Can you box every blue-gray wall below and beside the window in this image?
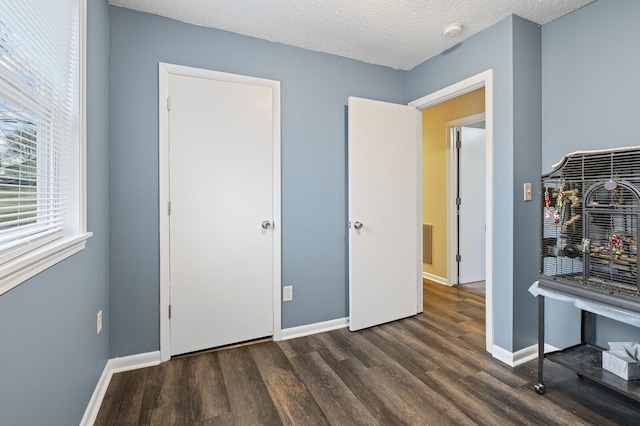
[0,0,109,426]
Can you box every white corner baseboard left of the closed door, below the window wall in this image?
[80,351,160,426]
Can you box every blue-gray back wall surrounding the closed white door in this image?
[110,7,406,356]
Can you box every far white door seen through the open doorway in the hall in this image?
[458,127,486,284]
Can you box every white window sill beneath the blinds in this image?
[0,232,93,295]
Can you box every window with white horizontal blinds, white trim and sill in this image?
[0,0,91,294]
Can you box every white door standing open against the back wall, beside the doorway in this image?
[348,97,422,330]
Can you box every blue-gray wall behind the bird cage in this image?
[542,0,640,347]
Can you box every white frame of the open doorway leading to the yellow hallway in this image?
[409,69,494,354]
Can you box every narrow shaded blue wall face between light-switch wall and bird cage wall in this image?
[512,17,542,351]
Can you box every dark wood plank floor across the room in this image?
[95,281,640,425]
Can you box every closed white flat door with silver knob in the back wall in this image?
[168,73,279,355]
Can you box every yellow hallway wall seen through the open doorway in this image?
[422,88,484,279]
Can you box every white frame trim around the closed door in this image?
[158,62,282,362]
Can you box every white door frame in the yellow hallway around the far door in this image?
[447,112,486,286]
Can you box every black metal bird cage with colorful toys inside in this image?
[540,147,640,310]
